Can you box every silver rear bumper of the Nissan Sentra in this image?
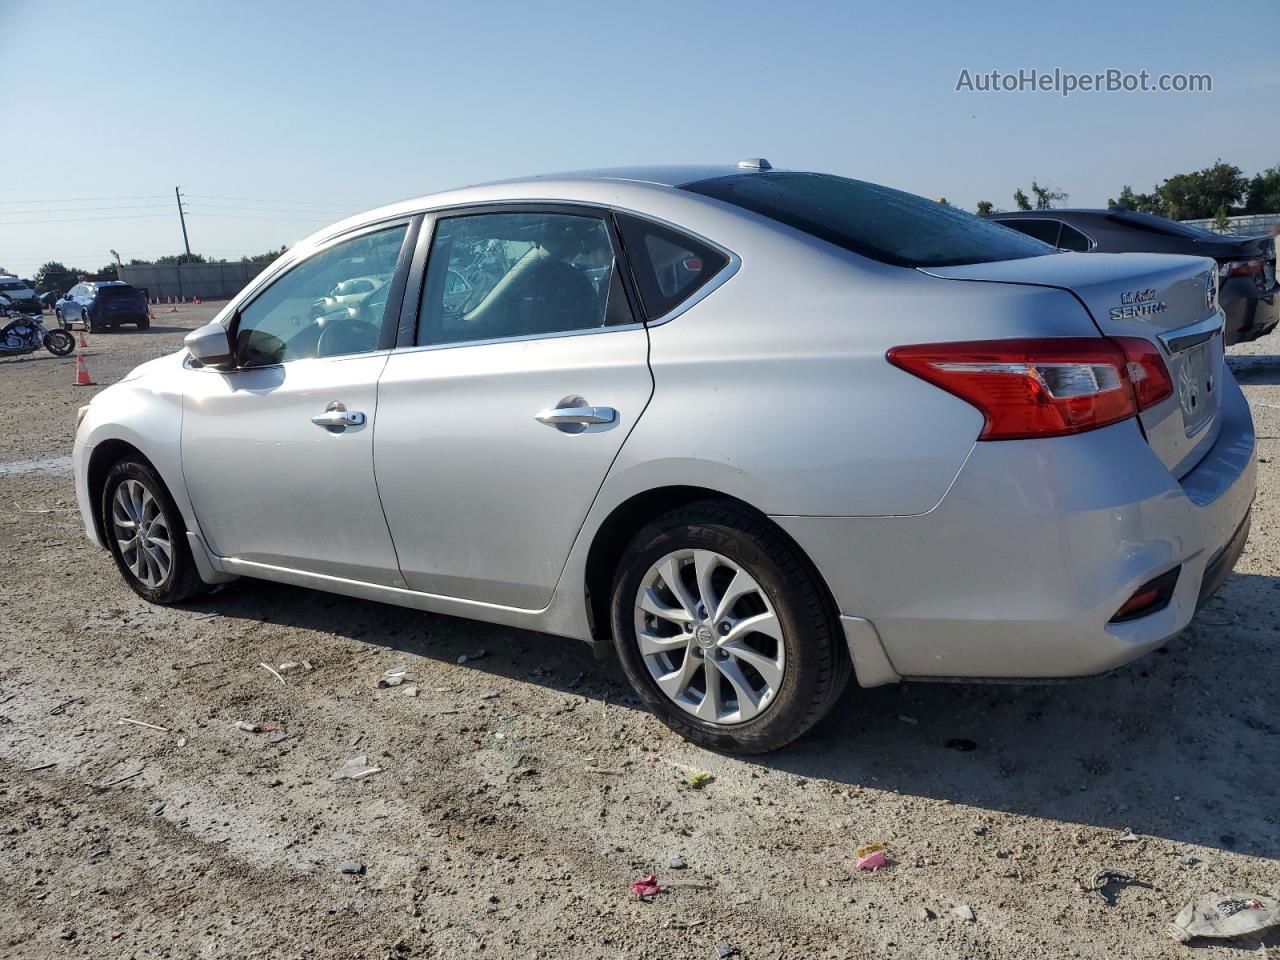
[776,376,1256,682]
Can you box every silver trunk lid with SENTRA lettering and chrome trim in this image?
[925,253,1224,477]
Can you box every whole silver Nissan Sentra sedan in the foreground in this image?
[73,161,1256,751]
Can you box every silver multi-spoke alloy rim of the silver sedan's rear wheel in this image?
[635,549,786,724]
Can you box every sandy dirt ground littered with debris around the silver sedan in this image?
[0,305,1280,960]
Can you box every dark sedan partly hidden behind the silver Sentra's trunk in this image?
[989,209,1280,344]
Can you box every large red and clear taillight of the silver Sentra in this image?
[888,337,1172,440]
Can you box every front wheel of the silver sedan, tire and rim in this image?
[100,460,207,603]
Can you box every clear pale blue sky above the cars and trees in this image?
[0,0,1280,275]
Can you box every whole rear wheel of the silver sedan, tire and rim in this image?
[612,500,850,753]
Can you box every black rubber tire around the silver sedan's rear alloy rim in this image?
[609,500,852,754]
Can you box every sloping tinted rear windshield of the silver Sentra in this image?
[684,173,1055,266]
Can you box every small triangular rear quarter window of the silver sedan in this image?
[617,214,728,320]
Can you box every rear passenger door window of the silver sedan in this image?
[417,212,632,346]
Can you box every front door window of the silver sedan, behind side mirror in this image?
[236,225,408,366]
